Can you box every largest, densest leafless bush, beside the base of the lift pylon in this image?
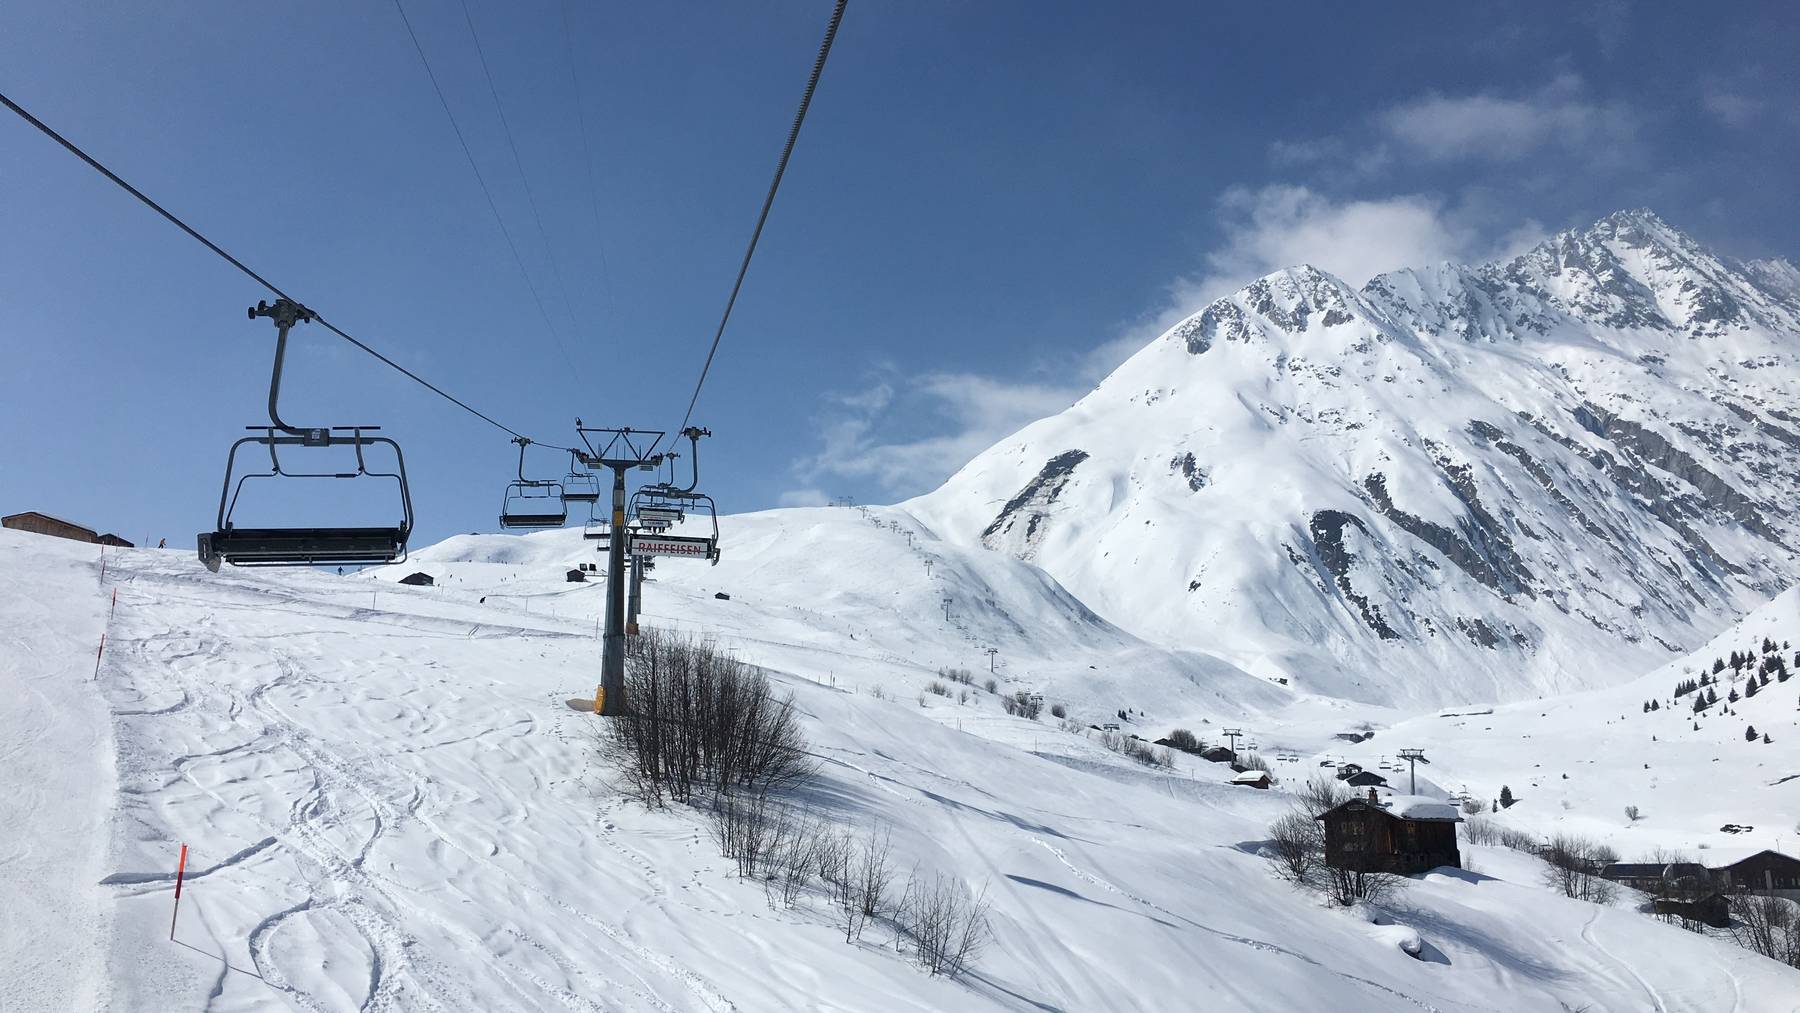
[603,630,817,806]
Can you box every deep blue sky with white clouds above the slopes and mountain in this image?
[0,0,1800,545]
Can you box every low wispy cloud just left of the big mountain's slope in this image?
[783,372,1085,502]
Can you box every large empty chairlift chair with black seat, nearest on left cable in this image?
[196,299,412,572]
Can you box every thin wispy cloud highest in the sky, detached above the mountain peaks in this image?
[1375,74,1636,162]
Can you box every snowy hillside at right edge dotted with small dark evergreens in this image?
[1330,588,1800,862]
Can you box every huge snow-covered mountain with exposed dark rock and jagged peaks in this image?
[904,211,1800,705]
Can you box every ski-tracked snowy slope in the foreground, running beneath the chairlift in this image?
[0,511,1800,1011]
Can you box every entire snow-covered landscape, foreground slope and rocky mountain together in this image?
[10,212,1800,1013]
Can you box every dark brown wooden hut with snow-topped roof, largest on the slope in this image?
[1319,788,1462,874]
